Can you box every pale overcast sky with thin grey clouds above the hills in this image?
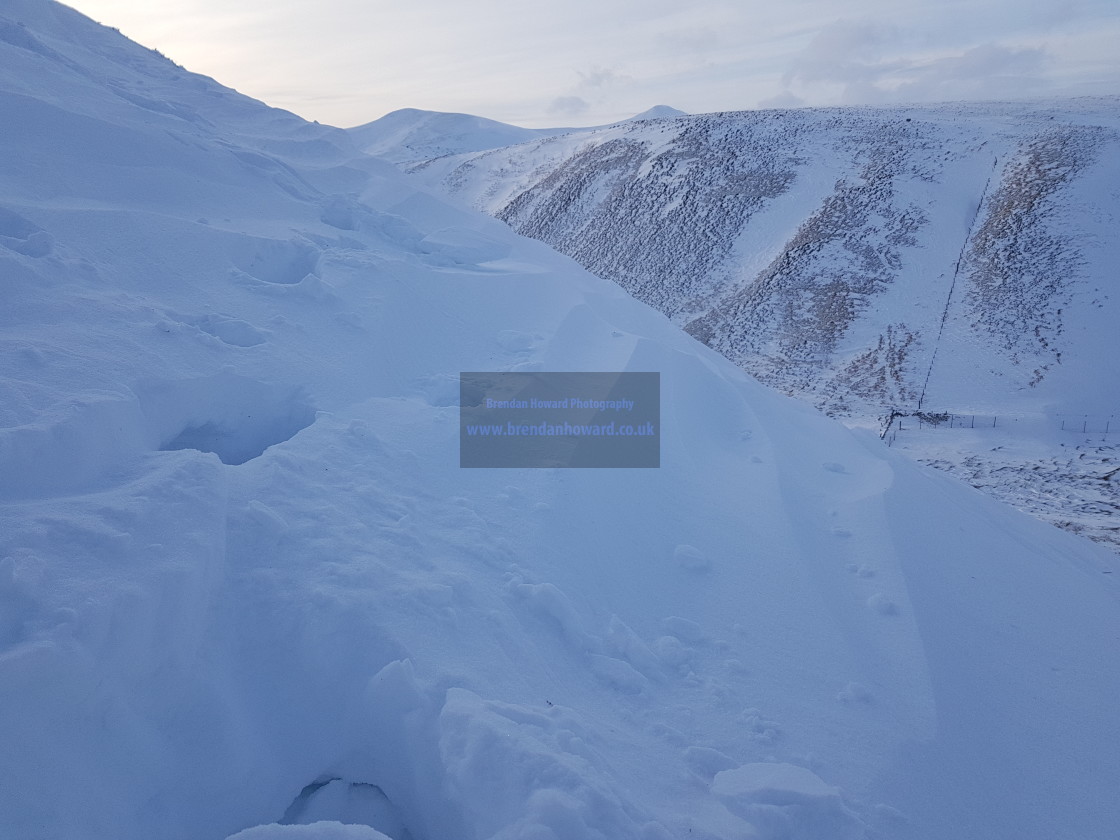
[68,0,1120,128]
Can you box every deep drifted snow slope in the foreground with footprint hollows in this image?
[0,0,1120,840]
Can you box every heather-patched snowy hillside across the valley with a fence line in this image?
[412,97,1120,545]
